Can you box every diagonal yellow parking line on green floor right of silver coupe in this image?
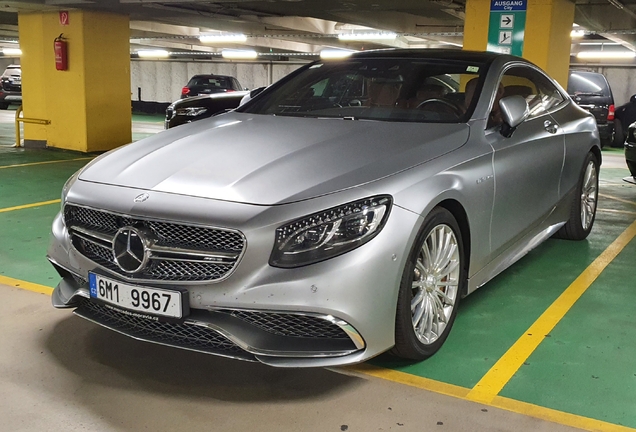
[468,221,636,403]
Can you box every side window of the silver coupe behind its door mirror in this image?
[493,66,565,118]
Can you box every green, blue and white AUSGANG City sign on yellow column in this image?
[487,0,528,56]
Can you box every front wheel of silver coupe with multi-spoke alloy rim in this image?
[391,207,467,360]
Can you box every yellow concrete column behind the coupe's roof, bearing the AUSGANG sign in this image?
[464,0,574,87]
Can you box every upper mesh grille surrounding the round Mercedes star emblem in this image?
[64,204,245,282]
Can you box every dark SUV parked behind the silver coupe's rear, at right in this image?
[568,70,615,146]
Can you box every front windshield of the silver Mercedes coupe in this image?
[241,58,486,123]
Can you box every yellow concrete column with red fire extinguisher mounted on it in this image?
[18,10,131,152]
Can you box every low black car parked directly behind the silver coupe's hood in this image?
[164,91,249,129]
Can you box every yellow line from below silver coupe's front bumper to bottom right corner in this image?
[348,364,636,432]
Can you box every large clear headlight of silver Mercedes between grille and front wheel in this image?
[269,195,392,268]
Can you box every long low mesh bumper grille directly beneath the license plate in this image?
[76,299,249,358]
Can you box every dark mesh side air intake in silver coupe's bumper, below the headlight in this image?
[230,310,349,340]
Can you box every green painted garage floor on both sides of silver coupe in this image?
[0,135,636,428]
